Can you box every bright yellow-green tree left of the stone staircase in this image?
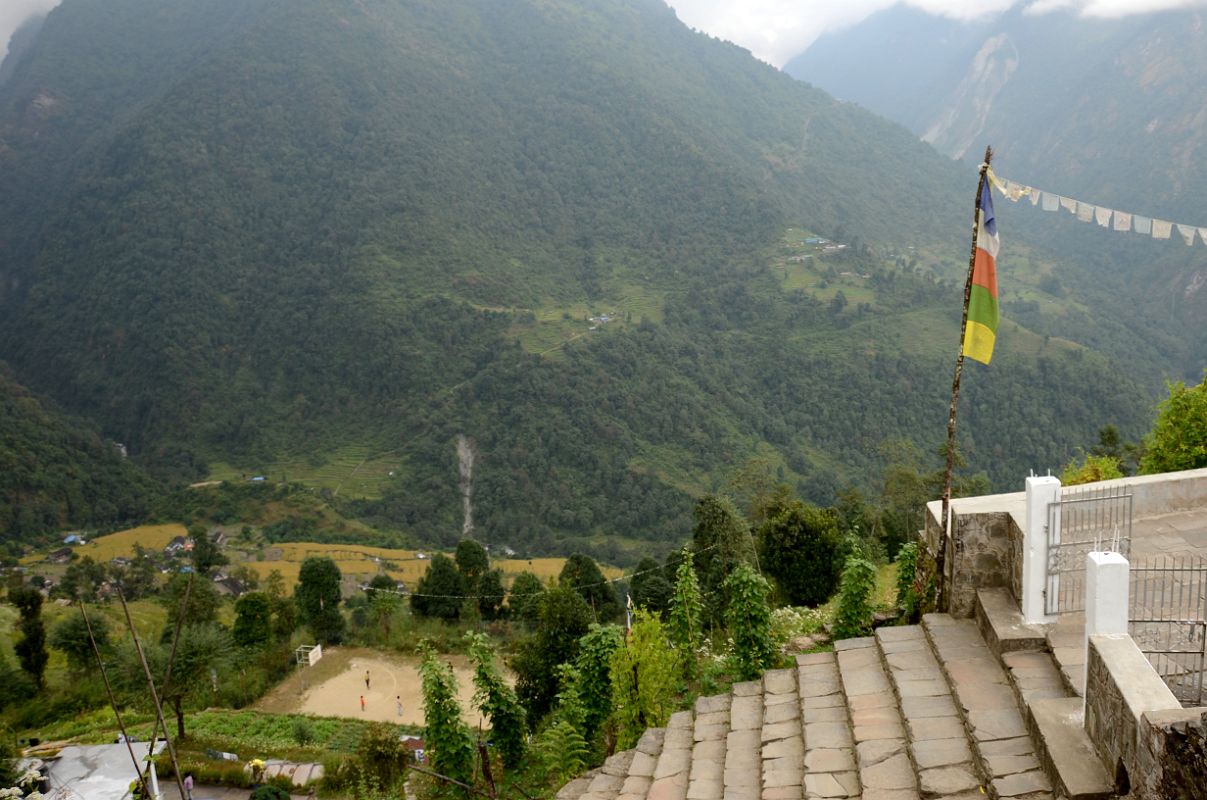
[612,608,678,749]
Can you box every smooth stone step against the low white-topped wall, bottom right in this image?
[1027,697,1115,800]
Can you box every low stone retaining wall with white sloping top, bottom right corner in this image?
[1085,635,1207,800]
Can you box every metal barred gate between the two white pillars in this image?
[1044,486,1132,614]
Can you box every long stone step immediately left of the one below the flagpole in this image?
[876,625,984,798]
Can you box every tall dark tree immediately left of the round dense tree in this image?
[692,495,754,621]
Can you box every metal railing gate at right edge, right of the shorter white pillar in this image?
[1127,556,1207,707]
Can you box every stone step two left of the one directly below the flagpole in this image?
[835,636,907,800]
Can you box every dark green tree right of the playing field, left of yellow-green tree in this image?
[512,585,594,725]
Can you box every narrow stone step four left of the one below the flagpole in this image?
[760,668,805,800]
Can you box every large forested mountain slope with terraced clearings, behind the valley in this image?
[0,0,1164,548]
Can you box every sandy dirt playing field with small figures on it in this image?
[256,648,504,729]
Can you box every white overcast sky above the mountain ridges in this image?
[7,0,1207,66]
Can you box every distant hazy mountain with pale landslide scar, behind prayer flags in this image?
[786,4,1207,371]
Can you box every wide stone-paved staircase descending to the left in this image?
[558,603,1114,800]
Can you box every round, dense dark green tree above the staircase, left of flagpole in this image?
[758,501,844,606]
